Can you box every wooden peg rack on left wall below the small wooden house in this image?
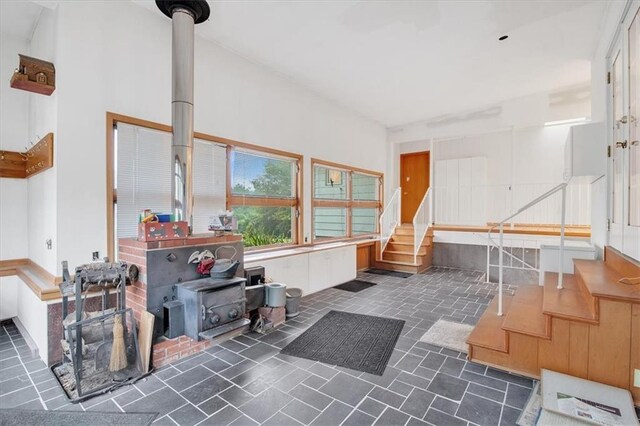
[0,133,53,179]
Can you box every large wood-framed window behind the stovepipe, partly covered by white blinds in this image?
[107,113,302,259]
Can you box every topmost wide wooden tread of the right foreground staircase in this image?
[573,259,640,303]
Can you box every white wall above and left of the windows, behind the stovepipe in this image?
[16,1,389,274]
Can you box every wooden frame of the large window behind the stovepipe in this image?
[106,112,304,259]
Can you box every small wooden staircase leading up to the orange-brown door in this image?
[375,224,433,274]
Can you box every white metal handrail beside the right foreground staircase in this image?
[487,182,568,316]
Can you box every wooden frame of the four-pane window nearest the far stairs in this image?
[311,158,384,244]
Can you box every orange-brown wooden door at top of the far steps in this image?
[400,151,429,223]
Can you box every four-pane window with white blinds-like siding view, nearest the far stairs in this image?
[312,160,382,241]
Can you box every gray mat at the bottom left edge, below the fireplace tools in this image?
[0,408,158,426]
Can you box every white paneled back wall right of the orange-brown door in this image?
[432,125,591,225]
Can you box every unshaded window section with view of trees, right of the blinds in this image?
[228,147,300,247]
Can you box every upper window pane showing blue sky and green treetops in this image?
[231,151,295,198]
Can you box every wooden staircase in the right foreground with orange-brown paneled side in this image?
[467,247,640,404]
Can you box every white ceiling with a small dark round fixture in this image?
[0,0,608,127]
